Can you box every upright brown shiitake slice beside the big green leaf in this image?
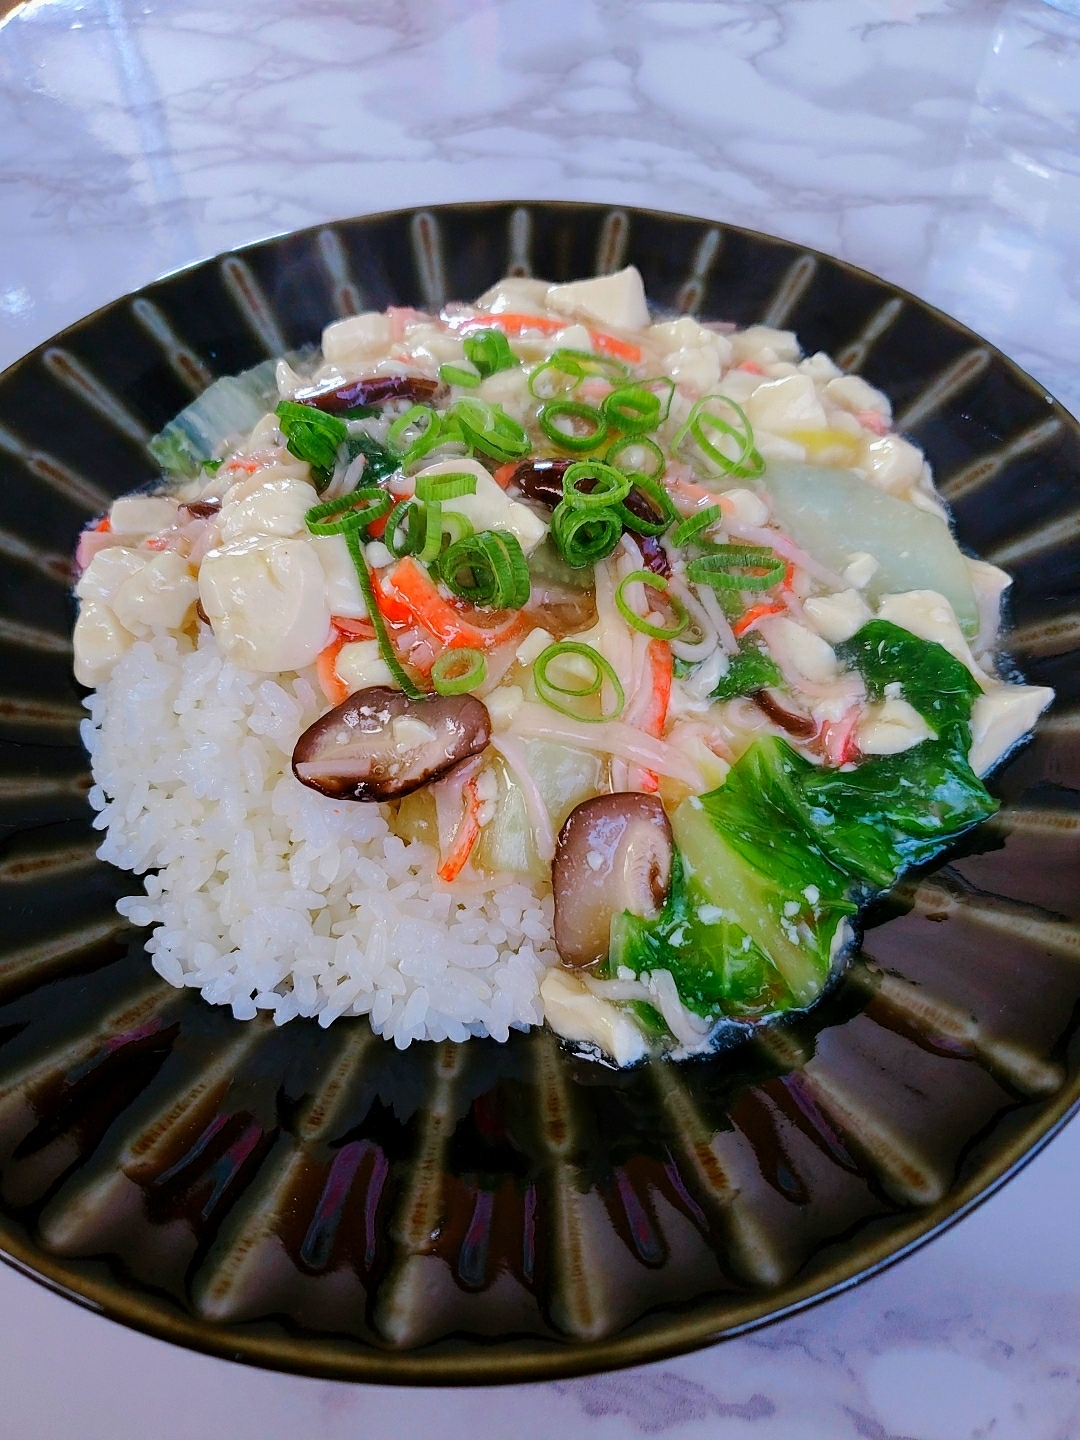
[552,791,674,969]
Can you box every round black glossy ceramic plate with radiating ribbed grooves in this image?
[0,203,1080,1384]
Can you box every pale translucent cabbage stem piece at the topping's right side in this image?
[757,461,979,636]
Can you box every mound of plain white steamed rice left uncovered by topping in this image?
[82,631,559,1048]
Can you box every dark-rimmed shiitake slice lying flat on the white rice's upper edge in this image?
[292,685,491,801]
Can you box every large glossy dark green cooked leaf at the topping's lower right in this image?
[611,621,996,1015]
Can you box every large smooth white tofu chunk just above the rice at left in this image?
[199,536,330,672]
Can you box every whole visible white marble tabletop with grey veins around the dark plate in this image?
[0,0,1080,1440]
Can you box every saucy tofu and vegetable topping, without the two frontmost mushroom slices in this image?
[75,269,1051,1063]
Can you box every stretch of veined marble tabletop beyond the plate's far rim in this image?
[0,0,1080,408]
